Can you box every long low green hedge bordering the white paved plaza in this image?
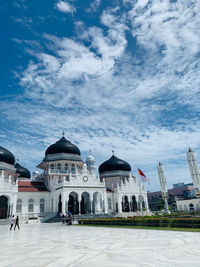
[78,217,200,228]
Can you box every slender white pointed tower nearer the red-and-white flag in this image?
[157,162,170,214]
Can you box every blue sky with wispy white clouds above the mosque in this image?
[0,0,200,193]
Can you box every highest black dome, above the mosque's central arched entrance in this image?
[45,136,81,156]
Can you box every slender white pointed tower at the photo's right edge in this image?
[187,148,200,199]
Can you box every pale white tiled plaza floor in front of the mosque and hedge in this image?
[0,224,200,267]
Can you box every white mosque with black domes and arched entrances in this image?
[0,133,149,219]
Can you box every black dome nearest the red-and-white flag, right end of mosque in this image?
[99,155,131,173]
